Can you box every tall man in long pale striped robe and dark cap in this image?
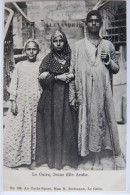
[69,10,125,170]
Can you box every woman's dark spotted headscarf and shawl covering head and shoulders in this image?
[39,30,71,75]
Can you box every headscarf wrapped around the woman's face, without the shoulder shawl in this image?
[50,30,71,60]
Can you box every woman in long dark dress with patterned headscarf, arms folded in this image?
[36,31,77,169]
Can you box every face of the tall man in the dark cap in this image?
[87,15,102,33]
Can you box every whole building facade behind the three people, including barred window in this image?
[4,0,127,122]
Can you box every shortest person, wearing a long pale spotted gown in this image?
[4,39,40,168]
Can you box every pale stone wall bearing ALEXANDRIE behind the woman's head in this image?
[27,0,97,55]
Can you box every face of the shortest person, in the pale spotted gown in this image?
[25,42,39,62]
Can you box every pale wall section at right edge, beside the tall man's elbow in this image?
[113,45,127,123]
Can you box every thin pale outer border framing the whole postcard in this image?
[0,0,130,195]
